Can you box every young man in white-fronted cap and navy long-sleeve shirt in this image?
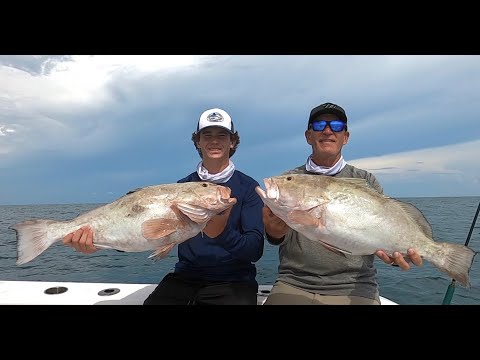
[64,108,264,305]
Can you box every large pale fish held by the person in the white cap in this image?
[10,182,237,265]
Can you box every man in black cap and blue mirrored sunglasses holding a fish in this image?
[263,103,422,305]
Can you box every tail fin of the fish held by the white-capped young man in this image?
[10,220,58,265]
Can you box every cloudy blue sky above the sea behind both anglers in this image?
[0,55,480,205]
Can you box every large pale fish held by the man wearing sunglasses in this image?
[256,174,476,288]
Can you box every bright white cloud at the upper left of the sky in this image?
[0,55,204,165]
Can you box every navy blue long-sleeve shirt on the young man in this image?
[175,170,264,281]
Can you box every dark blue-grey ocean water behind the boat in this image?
[0,197,480,305]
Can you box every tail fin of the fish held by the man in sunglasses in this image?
[431,242,477,288]
